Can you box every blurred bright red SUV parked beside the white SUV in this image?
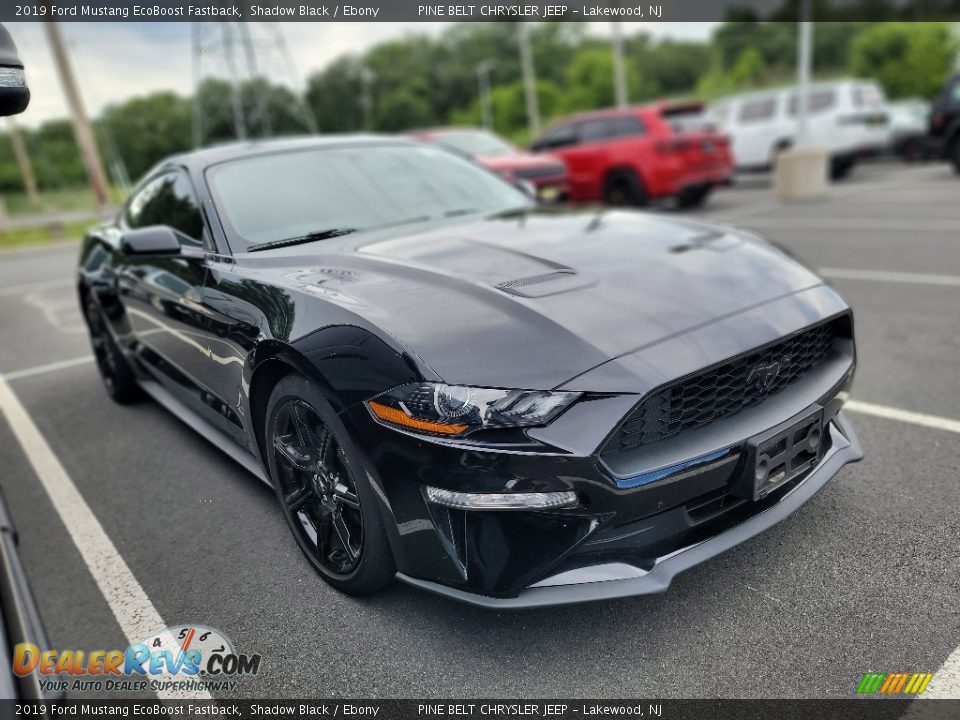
[531,102,733,207]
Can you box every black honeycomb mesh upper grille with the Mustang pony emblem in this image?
[604,321,841,453]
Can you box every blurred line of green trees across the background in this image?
[0,21,957,197]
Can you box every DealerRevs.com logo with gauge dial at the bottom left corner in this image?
[13,625,261,692]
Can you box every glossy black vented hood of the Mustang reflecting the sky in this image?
[253,212,821,390]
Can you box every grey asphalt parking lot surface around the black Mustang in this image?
[0,163,960,698]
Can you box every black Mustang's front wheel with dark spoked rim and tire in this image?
[264,375,396,595]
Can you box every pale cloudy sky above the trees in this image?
[6,22,716,127]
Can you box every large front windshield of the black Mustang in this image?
[207,145,532,246]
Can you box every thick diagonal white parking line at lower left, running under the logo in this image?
[0,376,211,700]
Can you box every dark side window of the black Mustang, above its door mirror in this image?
[124,171,203,245]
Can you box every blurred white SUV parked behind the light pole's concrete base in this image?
[710,80,889,180]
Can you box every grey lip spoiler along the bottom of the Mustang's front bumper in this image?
[397,412,863,609]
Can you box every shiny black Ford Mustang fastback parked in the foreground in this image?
[78,137,861,607]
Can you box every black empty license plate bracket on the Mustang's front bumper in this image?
[747,405,824,500]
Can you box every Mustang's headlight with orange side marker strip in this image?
[367,383,580,437]
